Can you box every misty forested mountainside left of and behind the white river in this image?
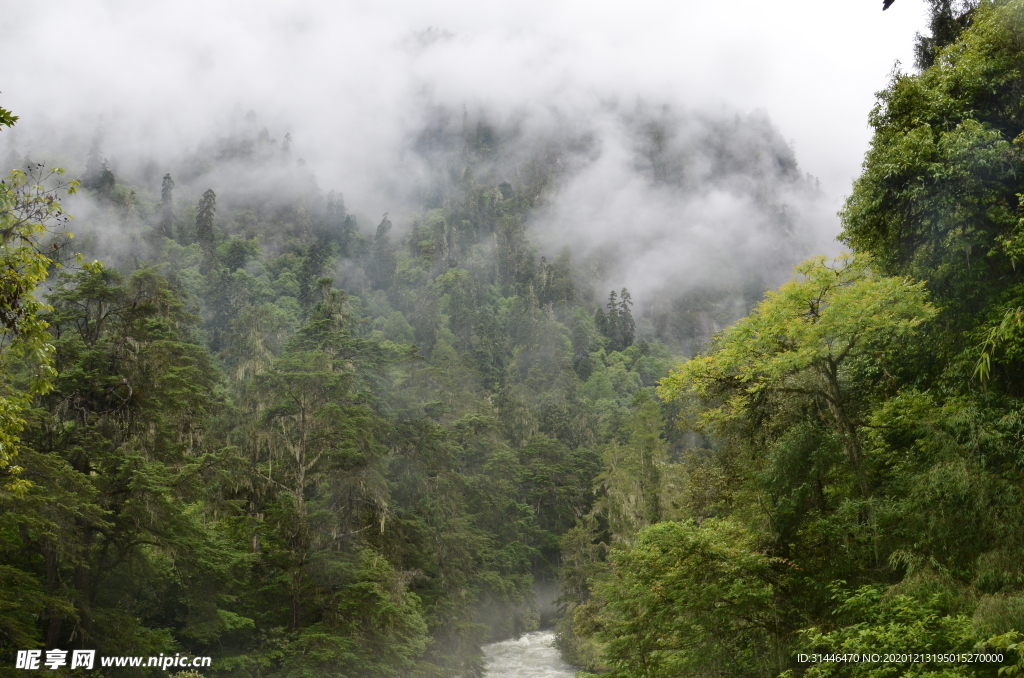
[0,91,813,678]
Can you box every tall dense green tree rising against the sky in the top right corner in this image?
[843,1,1024,394]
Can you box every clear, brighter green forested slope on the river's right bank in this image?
[560,0,1024,678]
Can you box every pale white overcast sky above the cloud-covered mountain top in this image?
[0,0,925,200]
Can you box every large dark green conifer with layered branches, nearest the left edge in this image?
[0,266,230,653]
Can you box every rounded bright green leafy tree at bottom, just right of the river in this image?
[596,520,779,678]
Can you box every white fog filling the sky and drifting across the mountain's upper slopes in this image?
[0,0,924,315]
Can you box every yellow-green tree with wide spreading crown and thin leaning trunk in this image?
[659,255,936,497]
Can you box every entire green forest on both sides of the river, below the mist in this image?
[6,0,1024,678]
